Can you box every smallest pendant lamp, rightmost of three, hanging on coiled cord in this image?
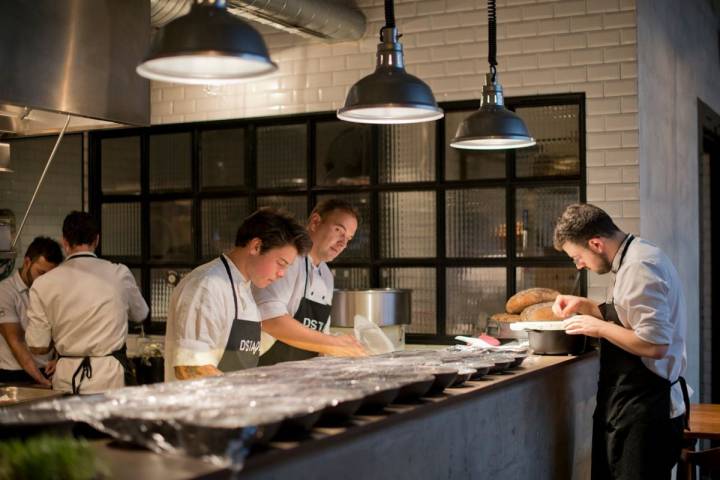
[450,0,535,150]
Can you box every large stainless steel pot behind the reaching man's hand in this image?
[330,288,412,327]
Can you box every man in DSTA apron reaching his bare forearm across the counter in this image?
[253,199,365,365]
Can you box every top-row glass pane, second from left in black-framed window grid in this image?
[150,132,192,192]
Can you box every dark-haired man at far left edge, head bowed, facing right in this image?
[0,237,63,387]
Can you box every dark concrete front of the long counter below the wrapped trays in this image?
[93,353,598,480]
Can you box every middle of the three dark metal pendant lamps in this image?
[337,0,443,124]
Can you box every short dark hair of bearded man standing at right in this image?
[553,203,622,250]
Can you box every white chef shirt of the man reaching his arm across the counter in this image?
[252,255,334,355]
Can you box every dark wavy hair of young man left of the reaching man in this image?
[235,207,312,255]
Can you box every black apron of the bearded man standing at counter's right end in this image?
[592,235,690,480]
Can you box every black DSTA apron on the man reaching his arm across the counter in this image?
[260,257,332,366]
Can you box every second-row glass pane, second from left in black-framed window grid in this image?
[150,200,194,261]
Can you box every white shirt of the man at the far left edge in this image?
[0,270,53,370]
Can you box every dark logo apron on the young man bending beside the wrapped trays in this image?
[218,257,260,372]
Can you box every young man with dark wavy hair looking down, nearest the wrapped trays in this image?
[165,208,311,382]
